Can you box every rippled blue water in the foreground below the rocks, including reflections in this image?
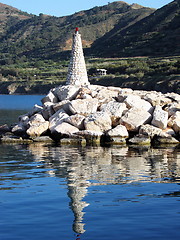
[0,94,180,240]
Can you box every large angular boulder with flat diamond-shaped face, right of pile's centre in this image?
[119,108,152,131]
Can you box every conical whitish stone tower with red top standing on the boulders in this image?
[66,28,90,86]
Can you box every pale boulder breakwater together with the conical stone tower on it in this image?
[0,28,180,145]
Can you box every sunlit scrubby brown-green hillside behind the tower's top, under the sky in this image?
[0,1,154,64]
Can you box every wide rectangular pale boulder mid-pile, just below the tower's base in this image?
[68,98,98,116]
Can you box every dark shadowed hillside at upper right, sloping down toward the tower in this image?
[91,0,180,57]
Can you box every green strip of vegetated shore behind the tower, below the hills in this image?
[0,57,180,94]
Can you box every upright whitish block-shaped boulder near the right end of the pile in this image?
[151,106,168,129]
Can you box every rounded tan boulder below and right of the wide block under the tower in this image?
[84,112,112,132]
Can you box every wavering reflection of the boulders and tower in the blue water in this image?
[26,143,180,233]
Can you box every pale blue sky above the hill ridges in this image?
[0,0,172,17]
